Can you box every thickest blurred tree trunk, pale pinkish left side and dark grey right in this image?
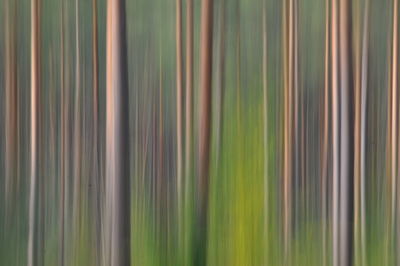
[106,0,130,266]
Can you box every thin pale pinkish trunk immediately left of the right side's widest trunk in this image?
[331,0,340,266]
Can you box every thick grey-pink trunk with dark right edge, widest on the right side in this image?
[339,0,354,266]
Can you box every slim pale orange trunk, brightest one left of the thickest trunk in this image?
[27,0,40,266]
